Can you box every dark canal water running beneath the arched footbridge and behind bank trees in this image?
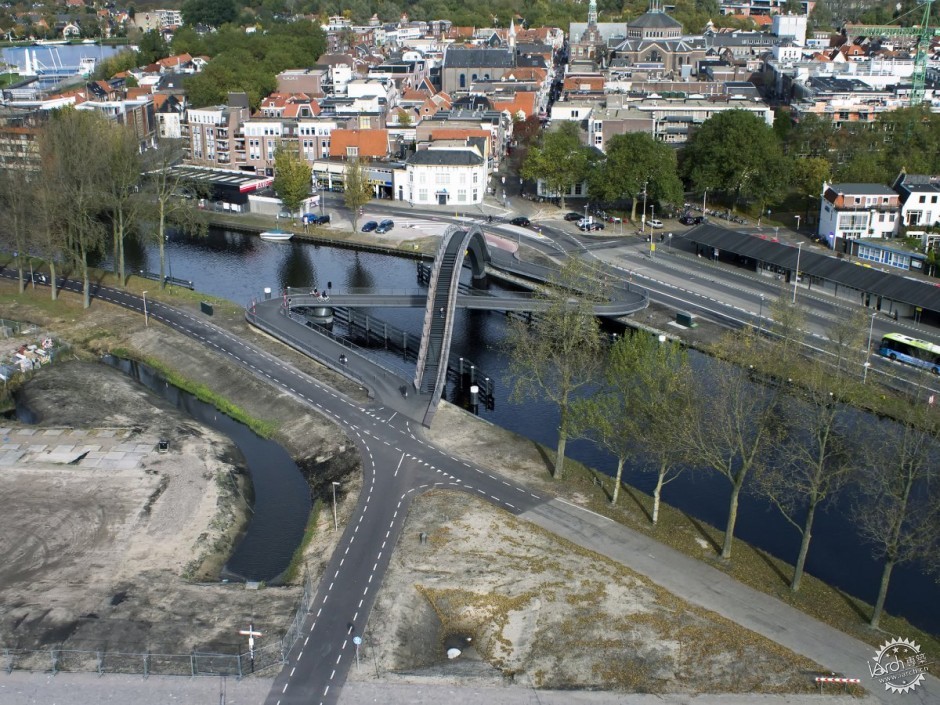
[114,230,940,634]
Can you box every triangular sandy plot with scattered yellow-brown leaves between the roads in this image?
[353,490,816,693]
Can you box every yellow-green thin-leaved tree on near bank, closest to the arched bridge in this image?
[505,257,605,479]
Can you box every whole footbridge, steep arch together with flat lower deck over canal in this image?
[247,225,649,425]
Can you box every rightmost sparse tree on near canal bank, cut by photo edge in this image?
[853,401,940,627]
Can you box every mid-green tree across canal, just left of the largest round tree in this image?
[589,132,682,220]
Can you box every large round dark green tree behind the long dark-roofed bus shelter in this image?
[682,110,784,208]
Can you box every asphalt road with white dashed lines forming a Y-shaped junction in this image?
[2,236,940,705]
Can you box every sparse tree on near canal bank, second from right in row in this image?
[756,361,856,592]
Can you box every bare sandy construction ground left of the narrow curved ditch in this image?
[0,362,298,668]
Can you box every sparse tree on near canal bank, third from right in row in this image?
[683,329,780,559]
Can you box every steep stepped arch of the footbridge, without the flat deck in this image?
[414,225,486,426]
